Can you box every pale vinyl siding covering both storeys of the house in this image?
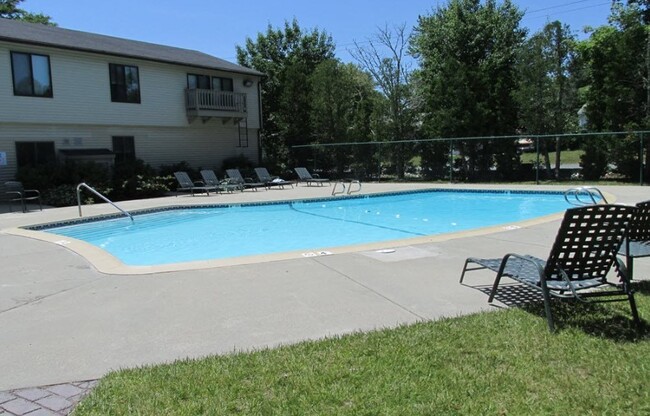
[0,42,260,183]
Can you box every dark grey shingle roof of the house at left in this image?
[0,18,263,75]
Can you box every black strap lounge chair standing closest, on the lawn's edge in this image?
[460,205,640,332]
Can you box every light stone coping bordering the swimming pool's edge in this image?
[2,188,616,275]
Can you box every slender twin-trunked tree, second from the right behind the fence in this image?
[517,21,579,178]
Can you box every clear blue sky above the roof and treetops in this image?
[20,0,611,62]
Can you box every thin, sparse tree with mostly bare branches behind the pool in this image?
[350,25,414,179]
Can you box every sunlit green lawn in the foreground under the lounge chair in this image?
[75,284,650,416]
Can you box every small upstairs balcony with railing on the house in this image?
[185,89,246,124]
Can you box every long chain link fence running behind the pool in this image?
[291,131,650,184]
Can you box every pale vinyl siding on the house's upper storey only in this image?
[0,42,259,128]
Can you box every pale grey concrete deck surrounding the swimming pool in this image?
[0,183,650,398]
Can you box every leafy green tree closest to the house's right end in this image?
[237,19,334,167]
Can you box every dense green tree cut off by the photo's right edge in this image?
[581,1,650,179]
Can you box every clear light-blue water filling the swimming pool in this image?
[43,191,569,266]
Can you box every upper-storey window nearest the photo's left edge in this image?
[11,52,52,97]
